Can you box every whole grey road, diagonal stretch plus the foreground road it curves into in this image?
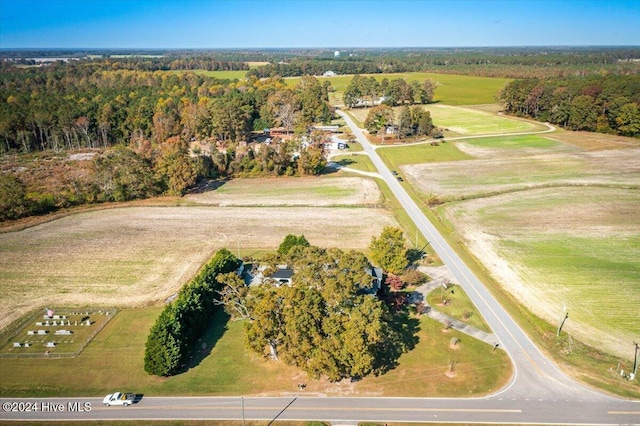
[0,111,640,424]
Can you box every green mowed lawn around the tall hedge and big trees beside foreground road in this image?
[0,308,512,397]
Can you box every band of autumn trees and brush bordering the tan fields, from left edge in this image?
[0,136,327,221]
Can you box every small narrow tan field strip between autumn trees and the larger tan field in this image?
[185,177,381,206]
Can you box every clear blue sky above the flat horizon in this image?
[0,0,640,48]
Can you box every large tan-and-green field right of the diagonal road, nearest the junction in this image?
[439,187,640,359]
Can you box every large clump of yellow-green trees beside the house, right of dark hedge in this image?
[215,236,413,381]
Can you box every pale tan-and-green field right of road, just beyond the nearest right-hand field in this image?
[404,141,640,200]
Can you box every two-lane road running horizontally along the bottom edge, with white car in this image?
[0,396,640,424]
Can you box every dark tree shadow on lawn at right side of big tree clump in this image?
[374,308,420,375]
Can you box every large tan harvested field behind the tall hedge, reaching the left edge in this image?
[0,179,397,328]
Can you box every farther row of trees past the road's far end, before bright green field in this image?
[343,74,436,108]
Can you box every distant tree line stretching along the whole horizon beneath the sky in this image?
[0,46,640,78]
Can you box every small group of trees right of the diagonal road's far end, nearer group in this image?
[364,104,442,139]
